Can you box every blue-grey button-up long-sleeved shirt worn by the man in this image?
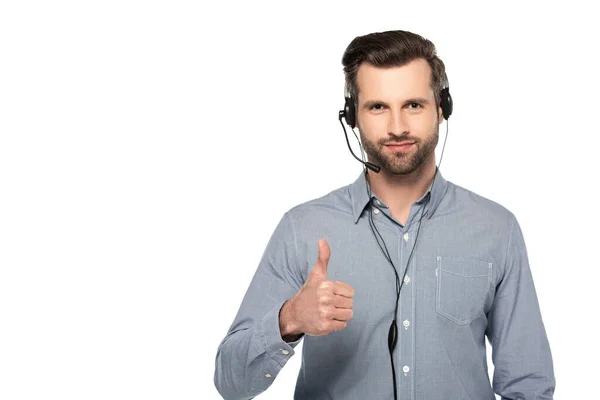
[214,170,555,400]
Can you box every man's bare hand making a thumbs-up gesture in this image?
[279,239,354,337]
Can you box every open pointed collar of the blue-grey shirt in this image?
[350,168,448,223]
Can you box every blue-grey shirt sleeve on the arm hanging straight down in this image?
[486,215,555,400]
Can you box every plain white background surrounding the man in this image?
[0,0,600,400]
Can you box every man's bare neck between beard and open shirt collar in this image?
[368,156,436,214]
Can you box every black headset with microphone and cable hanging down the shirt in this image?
[338,85,453,400]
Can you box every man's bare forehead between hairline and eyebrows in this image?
[356,58,433,100]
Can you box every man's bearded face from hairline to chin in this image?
[356,59,442,175]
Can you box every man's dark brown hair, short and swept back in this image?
[342,30,448,105]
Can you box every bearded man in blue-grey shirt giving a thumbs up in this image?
[215,31,555,400]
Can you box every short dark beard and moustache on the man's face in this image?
[359,124,440,175]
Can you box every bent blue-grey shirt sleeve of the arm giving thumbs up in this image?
[214,211,303,400]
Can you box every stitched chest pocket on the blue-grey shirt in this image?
[435,256,492,325]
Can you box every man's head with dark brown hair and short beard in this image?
[342,31,448,175]
